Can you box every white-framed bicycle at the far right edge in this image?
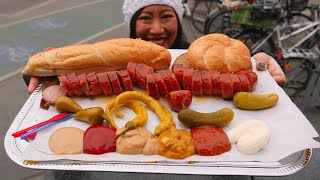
[235,2,320,100]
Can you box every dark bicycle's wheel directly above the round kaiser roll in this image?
[204,10,241,36]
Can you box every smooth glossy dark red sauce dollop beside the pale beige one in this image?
[83,124,117,154]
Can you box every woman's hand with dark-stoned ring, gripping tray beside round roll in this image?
[252,52,287,86]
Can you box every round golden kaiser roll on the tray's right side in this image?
[188,34,252,73]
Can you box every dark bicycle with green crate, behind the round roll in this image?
[204,0,312,49]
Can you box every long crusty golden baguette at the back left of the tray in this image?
[22,38,171,76]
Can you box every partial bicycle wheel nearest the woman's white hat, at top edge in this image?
[191,0,219,33]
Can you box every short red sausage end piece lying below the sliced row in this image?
[167,90,192,112]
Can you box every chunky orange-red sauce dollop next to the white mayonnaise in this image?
[190,126,231,156]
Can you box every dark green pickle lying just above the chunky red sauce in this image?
[178,108,234,128]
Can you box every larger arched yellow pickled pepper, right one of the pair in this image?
[114,91,173,136]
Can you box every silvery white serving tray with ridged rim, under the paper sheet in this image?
[4,50,312,176]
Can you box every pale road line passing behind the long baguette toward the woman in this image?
[0,22,125,82]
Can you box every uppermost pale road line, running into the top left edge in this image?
[0,0,105,29]
